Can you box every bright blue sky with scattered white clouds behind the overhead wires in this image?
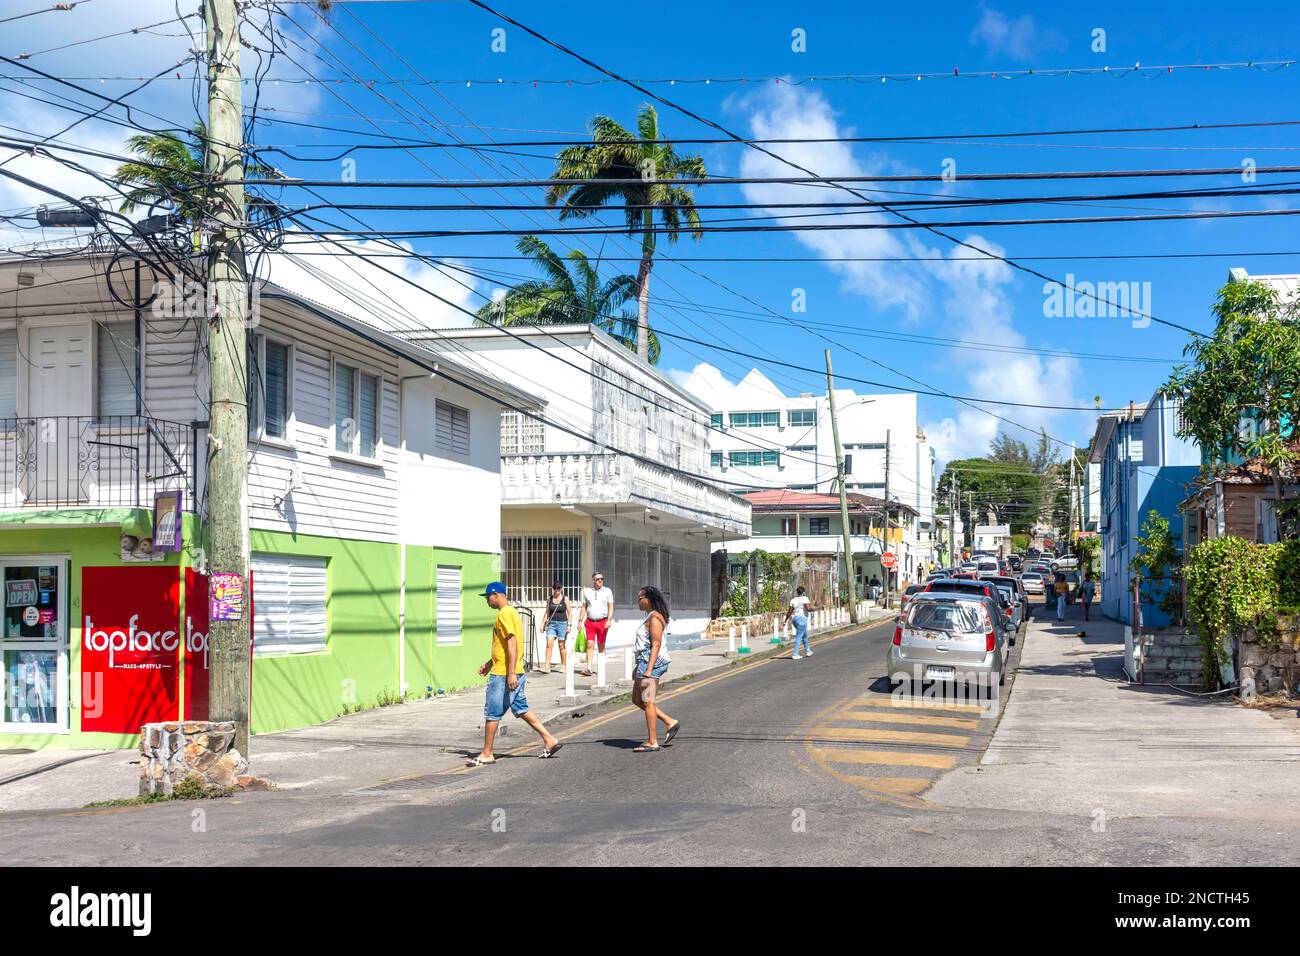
[0,0,1300,459]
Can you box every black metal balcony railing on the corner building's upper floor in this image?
[0,415,196,510]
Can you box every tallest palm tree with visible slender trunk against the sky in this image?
[546,104,709,358]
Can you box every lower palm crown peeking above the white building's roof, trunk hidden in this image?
[476,235,659,364]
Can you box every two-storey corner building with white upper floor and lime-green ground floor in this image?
[0,256,545,748]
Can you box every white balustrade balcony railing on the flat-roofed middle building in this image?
[501,454,750,536]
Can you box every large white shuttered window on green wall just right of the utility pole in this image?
[250,553,328,654]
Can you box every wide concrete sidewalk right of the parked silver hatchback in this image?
[926,605,1300,823]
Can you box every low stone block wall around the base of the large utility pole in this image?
[140,721,269,796]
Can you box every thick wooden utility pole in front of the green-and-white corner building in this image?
[203,0,251,756]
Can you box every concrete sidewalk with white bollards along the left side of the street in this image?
[0,607,885,813]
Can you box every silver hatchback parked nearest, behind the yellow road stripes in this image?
[885,592,1006,688]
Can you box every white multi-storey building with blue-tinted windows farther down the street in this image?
[683,368,937,576]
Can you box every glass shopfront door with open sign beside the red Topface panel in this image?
[0,555,69,734]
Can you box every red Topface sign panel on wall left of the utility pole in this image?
[81,566,181,734]
